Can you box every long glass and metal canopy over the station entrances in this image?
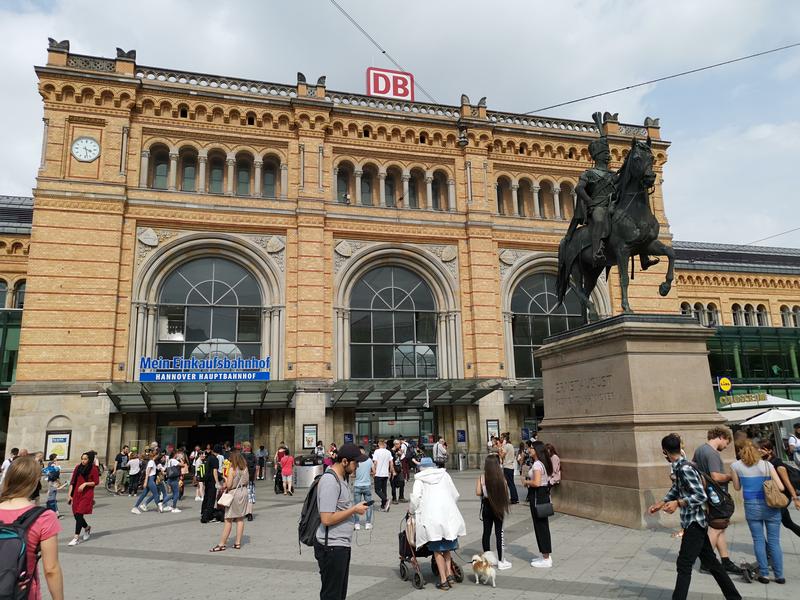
[105,379,542,412]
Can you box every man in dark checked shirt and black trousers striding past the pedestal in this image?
[649,433,742,600]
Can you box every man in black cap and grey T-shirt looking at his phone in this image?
[314,444,367,600]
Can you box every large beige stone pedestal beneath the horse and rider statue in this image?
[536,315,724,529]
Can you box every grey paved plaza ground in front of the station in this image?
[45,471,800,600]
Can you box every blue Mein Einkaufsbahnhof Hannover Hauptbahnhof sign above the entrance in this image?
[139,356,270,383]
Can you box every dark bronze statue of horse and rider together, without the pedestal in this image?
[557,112,675,314]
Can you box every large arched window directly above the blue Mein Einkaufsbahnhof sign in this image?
[156,257,262,359]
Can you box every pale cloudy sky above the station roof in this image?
[0,0,800,247]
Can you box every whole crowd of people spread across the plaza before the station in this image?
[0,423,800,600]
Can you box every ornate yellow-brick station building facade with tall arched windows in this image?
[0,43,800,456]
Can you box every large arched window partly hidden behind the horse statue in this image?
[511,273,586,379]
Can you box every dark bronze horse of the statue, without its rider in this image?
[556,137,675,313]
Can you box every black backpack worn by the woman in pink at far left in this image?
[0,506,47,600]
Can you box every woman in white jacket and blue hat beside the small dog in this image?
[409,456,467,590]
